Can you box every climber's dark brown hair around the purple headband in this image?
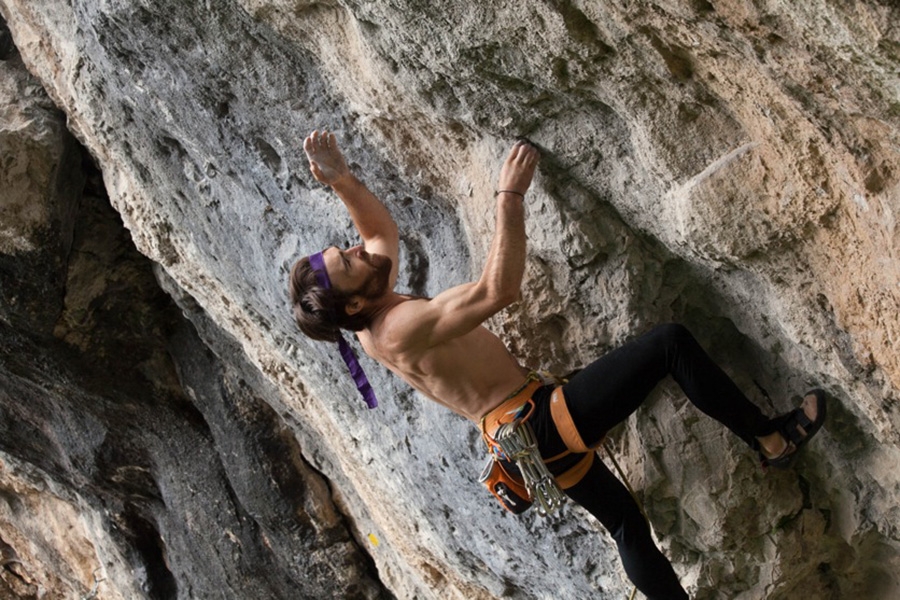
[290,256,369,342]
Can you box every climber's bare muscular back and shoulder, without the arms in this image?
[359,298,527,422]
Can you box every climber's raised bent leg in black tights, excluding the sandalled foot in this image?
[563,324,774,449]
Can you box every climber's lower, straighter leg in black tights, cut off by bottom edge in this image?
[566,459,688,600]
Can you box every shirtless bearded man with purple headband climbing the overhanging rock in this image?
[290,131,825,600]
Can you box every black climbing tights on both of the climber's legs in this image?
[535,325,772,600]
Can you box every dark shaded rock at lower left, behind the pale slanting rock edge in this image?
[0,45,388,599]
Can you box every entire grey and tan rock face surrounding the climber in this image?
[0,0,900,600]
